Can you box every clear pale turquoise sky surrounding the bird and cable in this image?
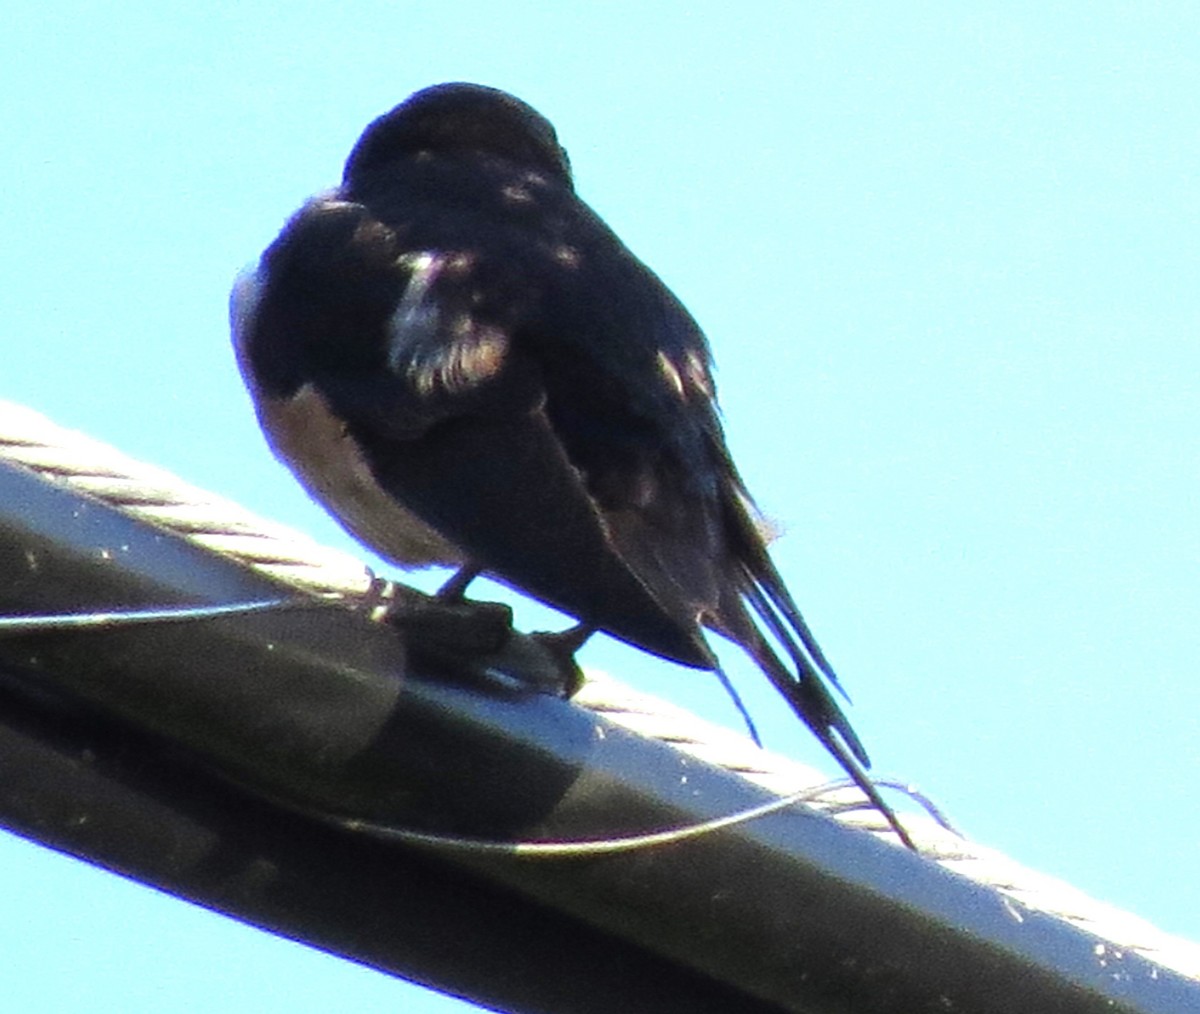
[0,0,1200,1014]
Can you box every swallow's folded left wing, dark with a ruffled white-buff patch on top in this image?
[302,234,713,667]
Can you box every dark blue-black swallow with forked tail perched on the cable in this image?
[232,84,911,845]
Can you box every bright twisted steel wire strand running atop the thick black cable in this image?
[0,401,1200,978]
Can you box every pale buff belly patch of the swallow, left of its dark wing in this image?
[257,384,464,566]
